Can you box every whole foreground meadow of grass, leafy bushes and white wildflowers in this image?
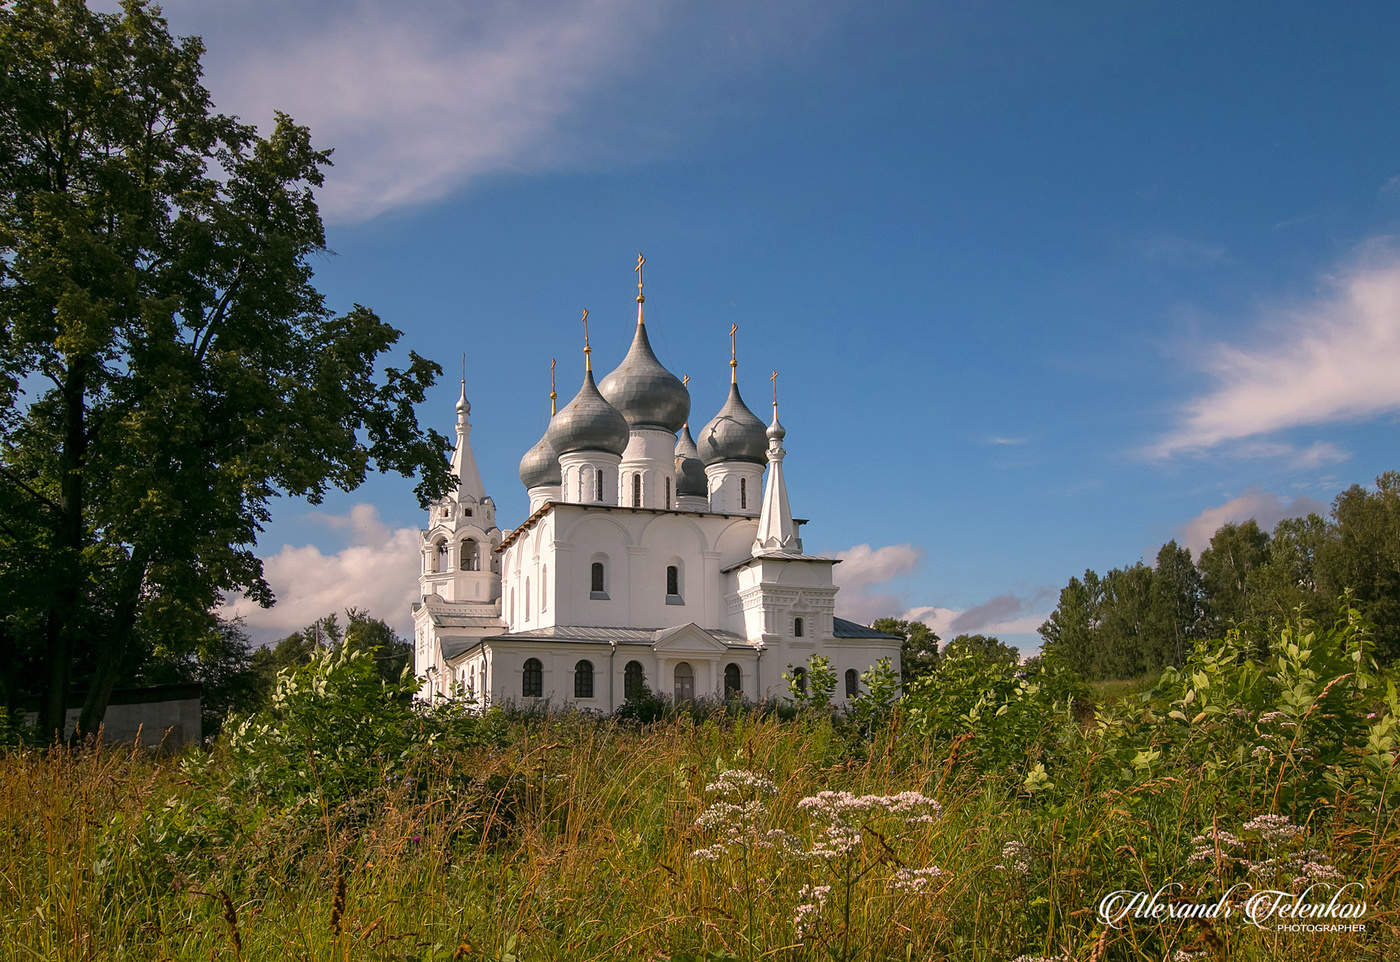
[0,609,1400,962]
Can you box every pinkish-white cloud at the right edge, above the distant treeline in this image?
[1147,251,1400,463]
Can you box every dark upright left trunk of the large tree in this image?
[41,358,87,738]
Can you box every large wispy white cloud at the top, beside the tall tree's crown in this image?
[150,0,832,221]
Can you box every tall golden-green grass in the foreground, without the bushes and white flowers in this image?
[0,716,1400,962]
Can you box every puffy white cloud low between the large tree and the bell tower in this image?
[221,504,419,641]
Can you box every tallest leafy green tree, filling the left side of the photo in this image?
[0,0,447,731]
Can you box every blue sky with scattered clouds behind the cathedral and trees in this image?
[167,0,1400,647]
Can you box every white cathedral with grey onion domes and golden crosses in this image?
[413,255,900,711]
